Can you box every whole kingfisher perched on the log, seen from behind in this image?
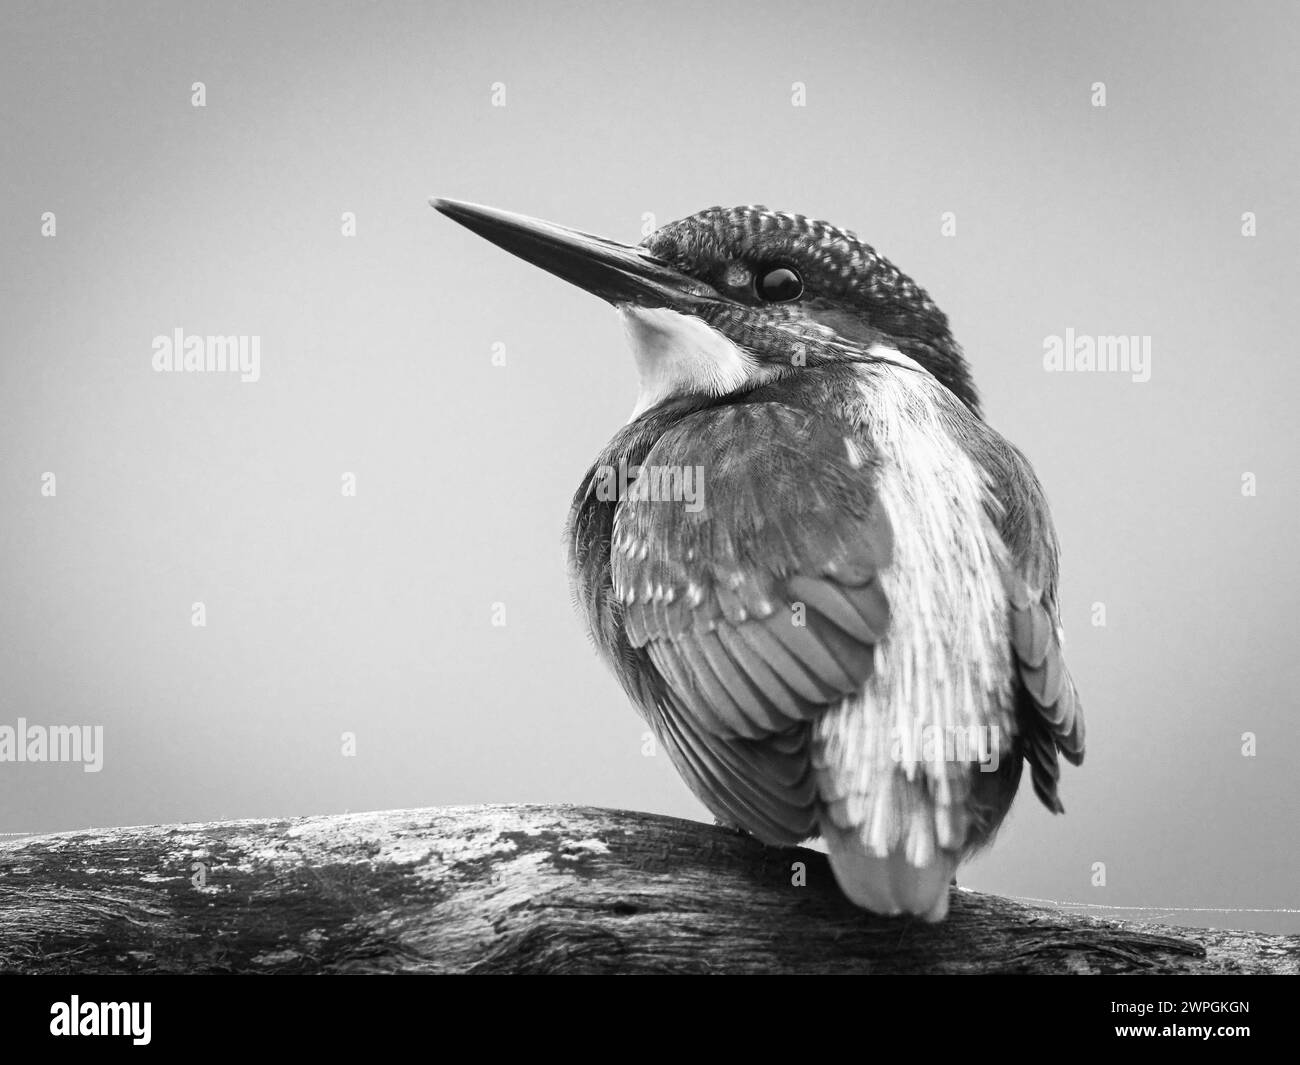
[430,199,1084,921]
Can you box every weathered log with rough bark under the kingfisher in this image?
[0,806,1300,973]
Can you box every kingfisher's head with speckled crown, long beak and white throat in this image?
[432,200,979,415]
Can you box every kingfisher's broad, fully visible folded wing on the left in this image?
[611,403,893,843]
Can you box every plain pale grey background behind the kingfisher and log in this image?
[0,0,1300,931]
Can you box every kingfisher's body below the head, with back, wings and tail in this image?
[571,359,1082,918]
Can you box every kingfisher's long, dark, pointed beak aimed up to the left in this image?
[429,199,716,307]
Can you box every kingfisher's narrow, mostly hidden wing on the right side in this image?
[983,433,1084,813]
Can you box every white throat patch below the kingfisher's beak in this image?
[619,304,771,420]
